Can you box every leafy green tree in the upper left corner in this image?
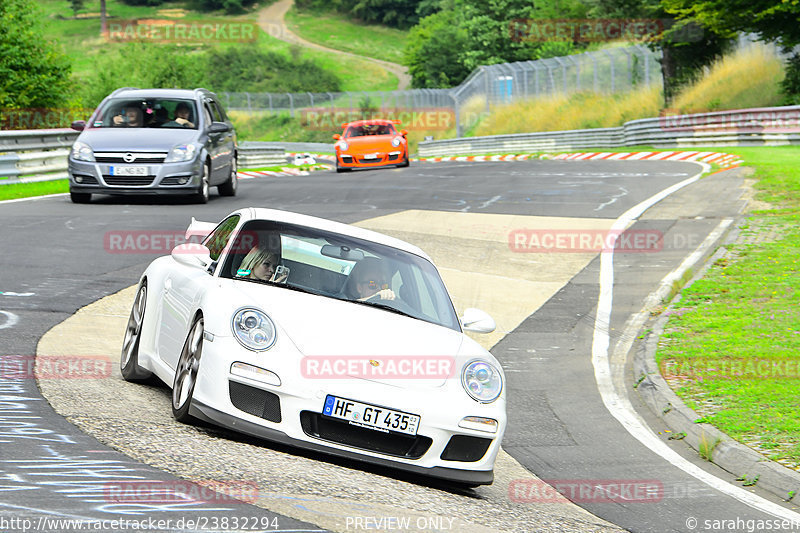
[0,0,72,108]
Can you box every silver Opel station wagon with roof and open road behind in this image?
[69,88,237,203]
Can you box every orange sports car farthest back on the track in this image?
[333,119,408,172]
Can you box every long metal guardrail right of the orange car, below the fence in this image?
[418,106,800,157]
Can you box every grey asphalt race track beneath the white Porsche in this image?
[0,161,800,532]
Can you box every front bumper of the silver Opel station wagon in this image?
[68,158,203,195]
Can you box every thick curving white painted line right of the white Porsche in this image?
[592,165,800,521]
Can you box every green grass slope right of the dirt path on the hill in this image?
[286,7,408,63]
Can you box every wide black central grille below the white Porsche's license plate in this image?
[300,411,433,459]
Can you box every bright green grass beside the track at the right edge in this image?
[656,146,800,467]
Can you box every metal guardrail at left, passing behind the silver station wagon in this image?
[0,135,286,185]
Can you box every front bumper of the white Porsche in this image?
[191,336,506,485]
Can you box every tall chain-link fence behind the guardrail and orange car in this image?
[221,45,661,137]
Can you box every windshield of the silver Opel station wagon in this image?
[89,98,197,129]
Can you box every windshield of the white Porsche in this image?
[220,220,460,331]
